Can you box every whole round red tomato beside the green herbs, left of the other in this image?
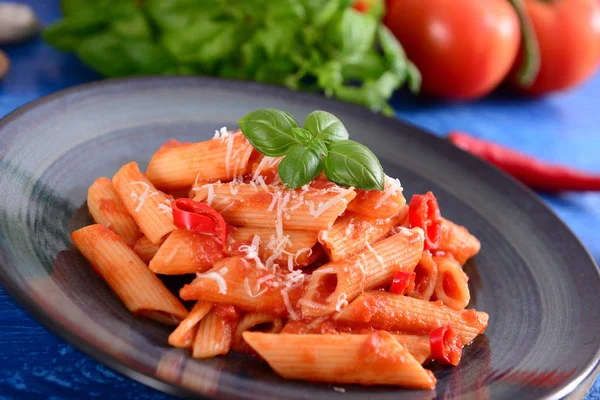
[384,0,521,99]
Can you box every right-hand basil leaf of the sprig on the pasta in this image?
[325,140,385,190]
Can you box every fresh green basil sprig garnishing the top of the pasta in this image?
[239,108,385,190]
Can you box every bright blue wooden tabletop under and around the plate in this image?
[0,0,600,400]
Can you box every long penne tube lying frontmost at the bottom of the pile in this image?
[243,332,436,389]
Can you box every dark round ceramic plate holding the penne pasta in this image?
[0,77,600,400]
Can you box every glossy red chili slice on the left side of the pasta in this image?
[171,199,227,247]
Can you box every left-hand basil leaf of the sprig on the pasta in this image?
[238,108,300,157]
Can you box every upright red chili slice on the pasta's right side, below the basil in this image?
[408,192,442,250]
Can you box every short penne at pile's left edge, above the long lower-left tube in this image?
[87,178,142,246]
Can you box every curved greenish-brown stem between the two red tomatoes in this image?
[509,0,541,87]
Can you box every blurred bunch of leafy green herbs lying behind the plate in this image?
[44,0,420,114]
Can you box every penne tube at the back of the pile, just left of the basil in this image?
[146,132,253,190]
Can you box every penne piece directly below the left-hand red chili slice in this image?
[148,229,225,275]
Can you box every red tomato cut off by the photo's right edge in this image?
[517,0,600,95]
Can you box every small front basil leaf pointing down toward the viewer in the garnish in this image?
[278,146,323,189]
